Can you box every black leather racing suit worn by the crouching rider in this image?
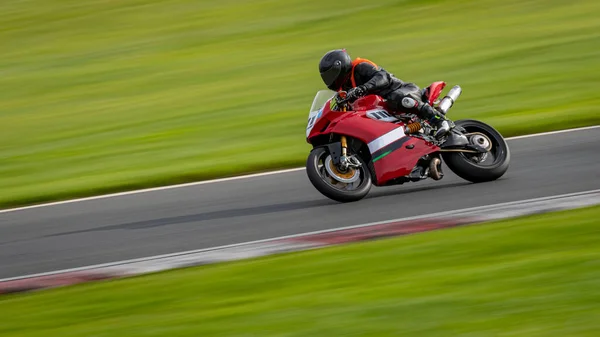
[342,62,443,121]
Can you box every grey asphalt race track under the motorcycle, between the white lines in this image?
[0,128,600,279]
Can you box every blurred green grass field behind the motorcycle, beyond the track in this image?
[0,0,600,206]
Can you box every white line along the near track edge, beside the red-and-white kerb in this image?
[0,189,600,282]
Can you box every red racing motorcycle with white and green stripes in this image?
[306,82,510,202]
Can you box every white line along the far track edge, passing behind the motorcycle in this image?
[0,125,600,214]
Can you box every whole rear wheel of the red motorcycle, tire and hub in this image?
[442,119,510,183]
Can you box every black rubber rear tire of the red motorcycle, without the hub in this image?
[442,119,510,183]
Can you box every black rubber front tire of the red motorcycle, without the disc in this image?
[306,147,372,202]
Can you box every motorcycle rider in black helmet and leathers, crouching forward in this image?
[319,49,450,137]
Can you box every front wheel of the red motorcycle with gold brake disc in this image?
[306,147,372,202]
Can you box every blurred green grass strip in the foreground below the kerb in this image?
[0,206,600,337]
